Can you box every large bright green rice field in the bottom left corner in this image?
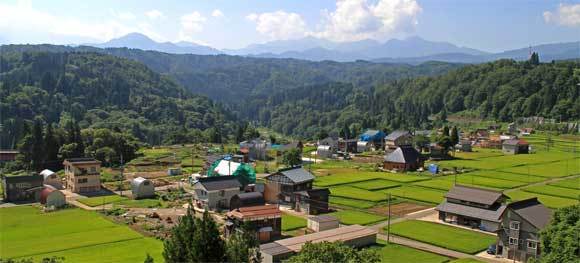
[0,206,163,262]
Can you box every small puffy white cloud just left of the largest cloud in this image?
[246,10,306,39]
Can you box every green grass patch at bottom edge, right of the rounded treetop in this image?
[369,240,449,263]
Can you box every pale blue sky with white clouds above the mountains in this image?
[0,0,580,52]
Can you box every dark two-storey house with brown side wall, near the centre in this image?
[264,166,329,216]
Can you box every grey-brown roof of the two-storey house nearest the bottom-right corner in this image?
[507,197,552,229]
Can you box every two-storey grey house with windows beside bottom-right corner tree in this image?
[496,198,552,262]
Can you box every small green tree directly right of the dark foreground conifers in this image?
[226,223,262,263]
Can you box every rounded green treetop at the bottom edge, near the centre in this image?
[286,241,381,263]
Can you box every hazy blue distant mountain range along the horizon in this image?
[82,33,580,64]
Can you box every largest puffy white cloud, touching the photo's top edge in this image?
[312,0,422,41]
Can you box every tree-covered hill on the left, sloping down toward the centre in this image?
[0,49,233,148]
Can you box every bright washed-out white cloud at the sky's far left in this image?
[0,2,164,43]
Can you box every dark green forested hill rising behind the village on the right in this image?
[260,60,580,137]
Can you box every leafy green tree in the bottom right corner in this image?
[539,204,580,263]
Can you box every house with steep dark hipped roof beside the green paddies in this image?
[383,146,423,171]
